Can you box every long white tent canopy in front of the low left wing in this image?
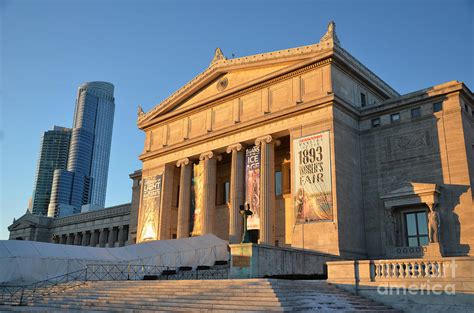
[0,235,229,285]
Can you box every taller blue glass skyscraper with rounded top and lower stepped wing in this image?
[48,82,115,217]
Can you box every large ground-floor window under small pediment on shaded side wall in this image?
[405,211,428,247]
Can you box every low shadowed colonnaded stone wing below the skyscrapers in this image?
[8,171,141,247]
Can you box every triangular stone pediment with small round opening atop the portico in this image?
[138,41,334,128]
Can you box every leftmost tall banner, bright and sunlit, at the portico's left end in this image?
[139,175,163,242]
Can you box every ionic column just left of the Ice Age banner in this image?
[227,143,245,244]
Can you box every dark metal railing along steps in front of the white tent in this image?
[0,263,229,305]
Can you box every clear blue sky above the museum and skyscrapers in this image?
[0,0,474,239]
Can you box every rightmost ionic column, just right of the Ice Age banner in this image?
[255,135,280,245]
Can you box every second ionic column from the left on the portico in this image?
[199,151,222,235]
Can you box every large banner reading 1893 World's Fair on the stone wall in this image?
[293,131,333,223]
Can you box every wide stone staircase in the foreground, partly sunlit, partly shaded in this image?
[0,279,399,313]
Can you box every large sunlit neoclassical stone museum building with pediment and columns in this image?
[137,23,474,258]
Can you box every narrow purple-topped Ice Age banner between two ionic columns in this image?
[245,146,260,229]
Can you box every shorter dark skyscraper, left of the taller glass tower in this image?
[31,126,71,215]
